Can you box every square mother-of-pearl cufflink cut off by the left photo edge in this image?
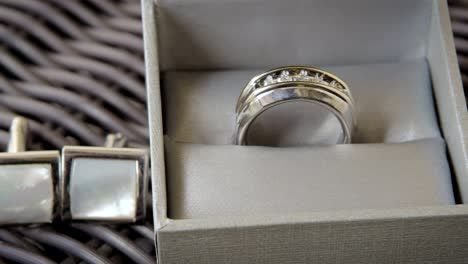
[0,117,60,225]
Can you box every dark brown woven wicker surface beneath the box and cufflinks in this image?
[0,0,468,264]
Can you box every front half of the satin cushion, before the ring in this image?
[166,138,454,219]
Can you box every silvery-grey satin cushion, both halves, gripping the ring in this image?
[162,59,454,219]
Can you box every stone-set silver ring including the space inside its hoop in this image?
[235,66,355,145]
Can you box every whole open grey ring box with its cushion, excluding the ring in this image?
[142,0,468,264]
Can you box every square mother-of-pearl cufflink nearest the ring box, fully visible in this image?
[60,135,148,222]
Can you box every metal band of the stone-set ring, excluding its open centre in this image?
[236,66,355,145]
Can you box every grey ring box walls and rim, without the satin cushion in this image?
[142,0,468,264]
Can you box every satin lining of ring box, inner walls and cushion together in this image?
[157,0,454,219]
